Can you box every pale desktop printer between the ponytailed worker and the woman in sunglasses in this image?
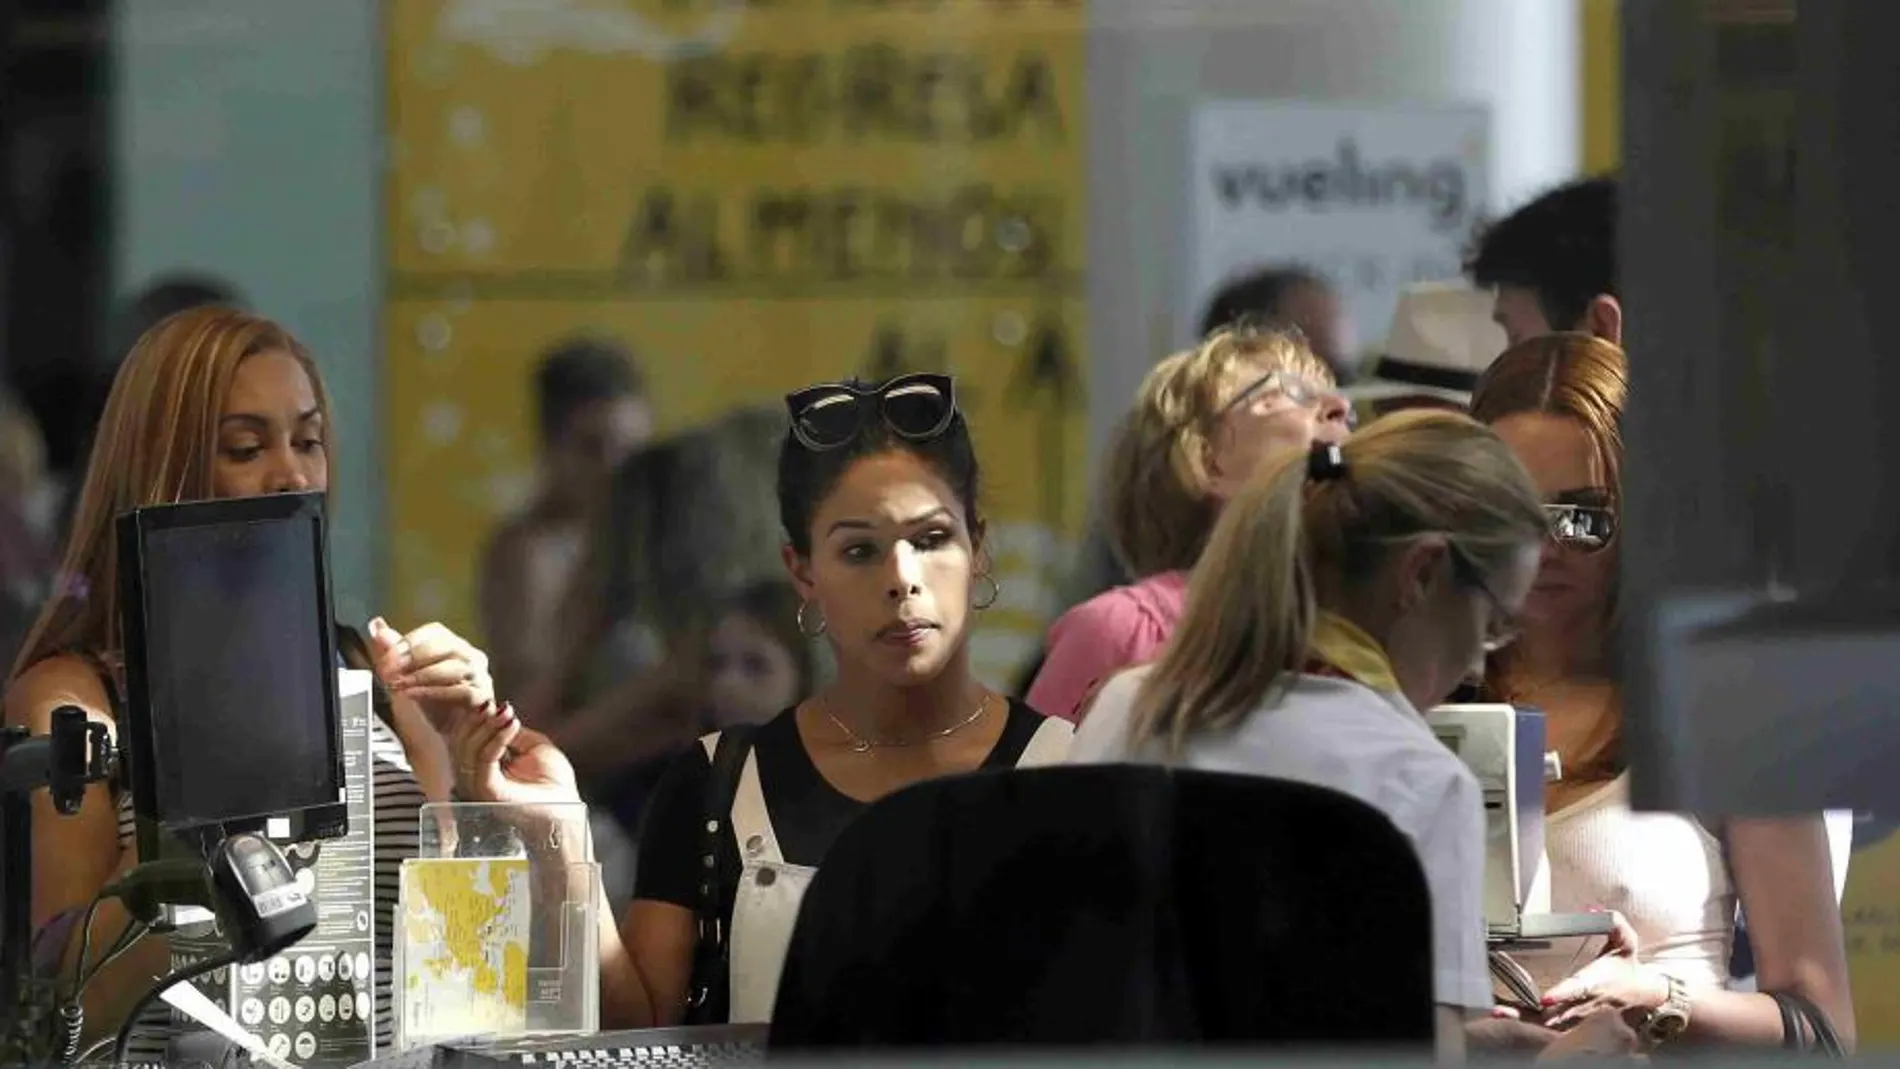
[1425,704,1611,946]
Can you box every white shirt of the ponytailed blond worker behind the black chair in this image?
[1070,666,1492,1010]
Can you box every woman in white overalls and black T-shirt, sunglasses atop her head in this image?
[442,374,1070,1027]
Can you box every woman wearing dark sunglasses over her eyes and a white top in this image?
[1473,334,1854,1046]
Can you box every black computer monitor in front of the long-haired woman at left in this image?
[118,494,350,860]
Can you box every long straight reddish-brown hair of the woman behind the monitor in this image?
[13,308,331,676]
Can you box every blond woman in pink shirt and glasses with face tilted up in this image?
[1028,327,1353,720]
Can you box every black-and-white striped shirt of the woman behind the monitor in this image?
[116,716,428,1063]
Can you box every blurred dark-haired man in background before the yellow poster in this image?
[481,336,654,693]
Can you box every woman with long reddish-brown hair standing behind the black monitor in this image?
[6,308,497,1061]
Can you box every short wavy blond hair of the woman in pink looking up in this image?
[1104,327,1336,577]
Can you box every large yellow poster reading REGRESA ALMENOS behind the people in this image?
[384,0,1087,682]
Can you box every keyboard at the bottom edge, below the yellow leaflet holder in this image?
[361,1025,768,1069]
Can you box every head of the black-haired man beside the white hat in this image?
[1465,177,1623,346]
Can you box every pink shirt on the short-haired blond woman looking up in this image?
[1026,572,1188,723]
